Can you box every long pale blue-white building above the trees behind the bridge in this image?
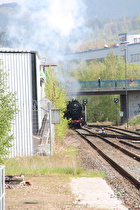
[65,33,140,64]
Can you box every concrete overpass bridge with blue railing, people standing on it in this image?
[67,79,140,123]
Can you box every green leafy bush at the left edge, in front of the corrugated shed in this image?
[0,64,17,162]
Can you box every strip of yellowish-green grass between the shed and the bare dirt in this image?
[5,146,105,177]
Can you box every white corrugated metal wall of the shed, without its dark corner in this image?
[0,51,39,157]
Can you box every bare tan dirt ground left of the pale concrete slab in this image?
[6,175,87,210]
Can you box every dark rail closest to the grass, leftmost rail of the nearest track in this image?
[75,130,140,189]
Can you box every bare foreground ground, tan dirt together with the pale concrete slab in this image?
[6,175,127,210]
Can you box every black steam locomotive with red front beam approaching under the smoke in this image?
[64,99,85,128]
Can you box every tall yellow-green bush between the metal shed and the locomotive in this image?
[45,68,67,139]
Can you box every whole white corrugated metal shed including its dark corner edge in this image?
[0,49,41,157]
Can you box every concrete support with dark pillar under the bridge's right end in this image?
[120,91,140,123]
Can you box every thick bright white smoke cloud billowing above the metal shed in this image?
[8,0,86,60]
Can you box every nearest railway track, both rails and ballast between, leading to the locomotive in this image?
[75,128,140,189]
